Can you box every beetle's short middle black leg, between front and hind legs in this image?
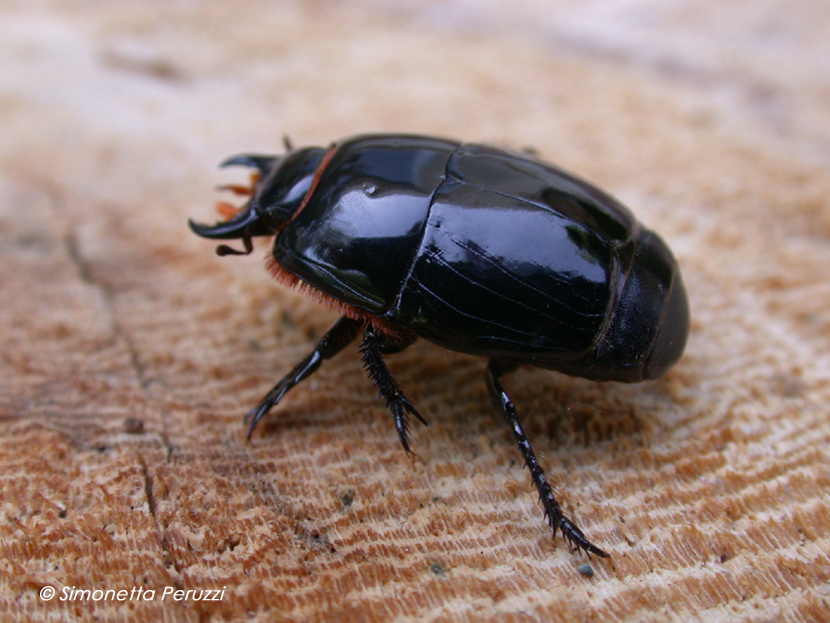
[360,323,427,454]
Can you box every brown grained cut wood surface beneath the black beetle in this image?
[0,0,830,623]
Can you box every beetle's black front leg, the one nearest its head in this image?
[245,316,363,439]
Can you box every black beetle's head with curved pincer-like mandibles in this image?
[188,147,326,255]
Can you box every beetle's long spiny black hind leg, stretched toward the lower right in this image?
[487,359,608,558]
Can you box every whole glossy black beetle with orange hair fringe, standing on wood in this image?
[189,134,689,557]
